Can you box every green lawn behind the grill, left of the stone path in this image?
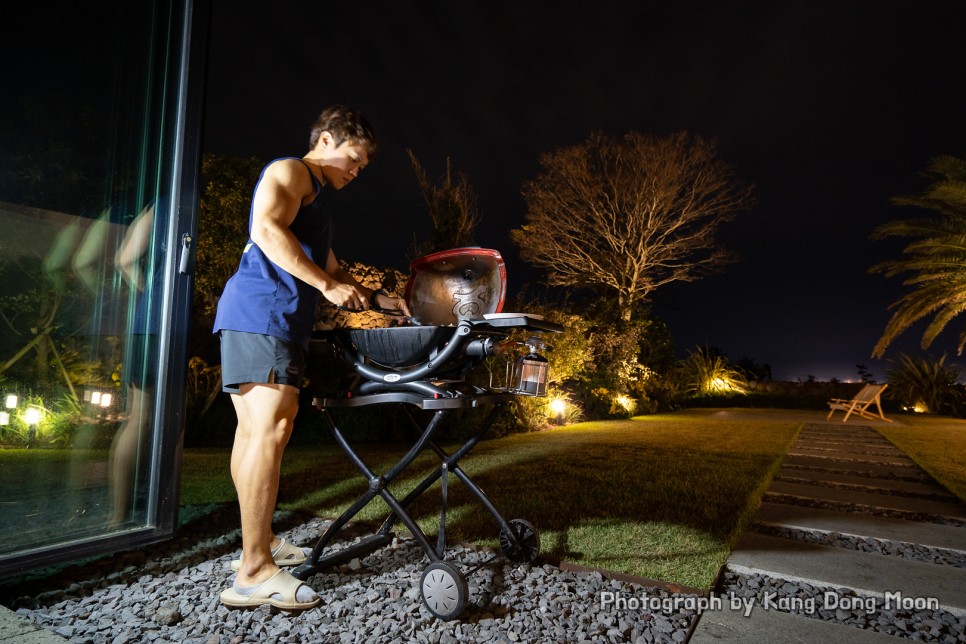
[181,410,801,589]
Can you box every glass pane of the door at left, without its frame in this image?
[0,2,170,558]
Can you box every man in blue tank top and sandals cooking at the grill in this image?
[214,105,409,610]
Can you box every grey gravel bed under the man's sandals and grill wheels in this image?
[0,508,702,644]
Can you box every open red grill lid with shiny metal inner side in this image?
[406,246,506,325]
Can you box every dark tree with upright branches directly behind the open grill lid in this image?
[406,150,480,257]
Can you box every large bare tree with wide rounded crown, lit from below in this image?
[511,132,753,320]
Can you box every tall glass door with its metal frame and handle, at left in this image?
[0,0,207,577]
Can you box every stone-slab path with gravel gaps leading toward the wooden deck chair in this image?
[690,422,966,644]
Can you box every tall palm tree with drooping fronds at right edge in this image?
[869,156,966,357]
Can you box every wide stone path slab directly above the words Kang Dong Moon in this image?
[725,533,966,616]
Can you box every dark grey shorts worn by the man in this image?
[221,331,305,394]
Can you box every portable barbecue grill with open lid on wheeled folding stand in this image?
[293,247,563,619]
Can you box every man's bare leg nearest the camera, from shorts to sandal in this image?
[231,383,298,587]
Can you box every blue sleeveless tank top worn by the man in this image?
[214,157,333,349]
